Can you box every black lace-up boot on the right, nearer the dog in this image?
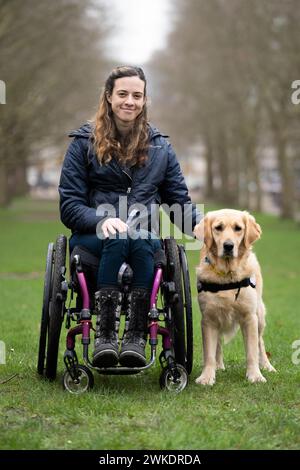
[119,288,150,367]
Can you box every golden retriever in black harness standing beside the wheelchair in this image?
[194,209,275,385]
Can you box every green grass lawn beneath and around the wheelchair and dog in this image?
[0,196,300,450]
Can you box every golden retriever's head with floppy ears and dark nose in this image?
[194,209,261,259]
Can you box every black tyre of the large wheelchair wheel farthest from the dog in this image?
[45,235,67,380]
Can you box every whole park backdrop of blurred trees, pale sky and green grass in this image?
[0,0,300,449]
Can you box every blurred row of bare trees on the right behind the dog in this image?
[151,0,300,217]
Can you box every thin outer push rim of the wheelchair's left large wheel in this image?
[37,243,53,375]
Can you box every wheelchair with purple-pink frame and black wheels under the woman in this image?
[37,235,193,394]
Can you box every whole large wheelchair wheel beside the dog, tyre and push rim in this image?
[165,238,193,374]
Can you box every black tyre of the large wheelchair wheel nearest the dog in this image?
[164,238,186,367]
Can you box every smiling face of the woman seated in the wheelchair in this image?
[107,76,146,124]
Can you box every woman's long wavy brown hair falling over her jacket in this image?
[92,66,149,166]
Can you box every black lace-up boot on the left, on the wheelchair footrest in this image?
[93,287,122,367]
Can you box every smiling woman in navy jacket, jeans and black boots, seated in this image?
[59,66,200,367]
